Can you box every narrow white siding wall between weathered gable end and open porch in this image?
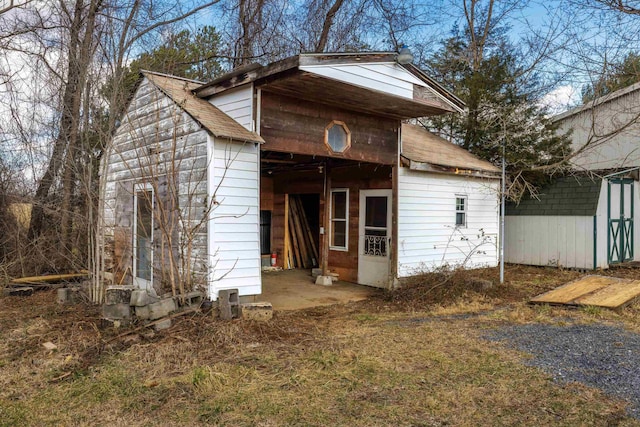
[209,138,262,299]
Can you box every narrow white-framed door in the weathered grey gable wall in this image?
[133,186,154,289]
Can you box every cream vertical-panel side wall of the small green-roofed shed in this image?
[504,216,596,269]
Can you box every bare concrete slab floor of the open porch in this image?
[258,269,381,310]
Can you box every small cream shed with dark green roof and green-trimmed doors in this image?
[505,170,640,269]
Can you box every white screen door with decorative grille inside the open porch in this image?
[358,190,391,288]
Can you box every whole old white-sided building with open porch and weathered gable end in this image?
[103,53,499,299]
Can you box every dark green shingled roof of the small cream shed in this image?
[506,176,602,216]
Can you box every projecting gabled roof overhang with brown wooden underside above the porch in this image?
[194,52,465,119]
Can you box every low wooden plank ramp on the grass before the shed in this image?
[529,276,640,309]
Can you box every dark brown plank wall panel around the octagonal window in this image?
[260,91,400,165]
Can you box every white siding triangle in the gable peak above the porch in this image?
[300,62,427,99]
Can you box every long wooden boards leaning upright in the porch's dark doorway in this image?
[284,195,318,268]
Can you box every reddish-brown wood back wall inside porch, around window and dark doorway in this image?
[262,164,391,283]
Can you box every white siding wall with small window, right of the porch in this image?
[398,168,499,277]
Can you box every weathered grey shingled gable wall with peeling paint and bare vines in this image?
[102,79,207,292]
